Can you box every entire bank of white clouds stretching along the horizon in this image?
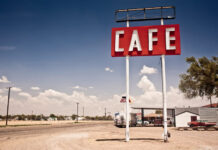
[0,65,217,116]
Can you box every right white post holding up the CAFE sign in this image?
[161,19,168,142]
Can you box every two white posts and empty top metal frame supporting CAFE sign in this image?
[112,6,178,142]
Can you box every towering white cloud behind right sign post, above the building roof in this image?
[134,73,212,107]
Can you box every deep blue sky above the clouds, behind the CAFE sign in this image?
[0,0,218,115]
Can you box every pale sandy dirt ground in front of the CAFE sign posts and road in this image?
[0,122,218,150]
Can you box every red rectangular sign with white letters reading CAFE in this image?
[111,24,181,57]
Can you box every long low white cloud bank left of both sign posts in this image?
[0,86,123,116]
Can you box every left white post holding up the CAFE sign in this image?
[126,21,129,142]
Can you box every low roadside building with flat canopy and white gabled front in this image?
[132,104,218,127]
